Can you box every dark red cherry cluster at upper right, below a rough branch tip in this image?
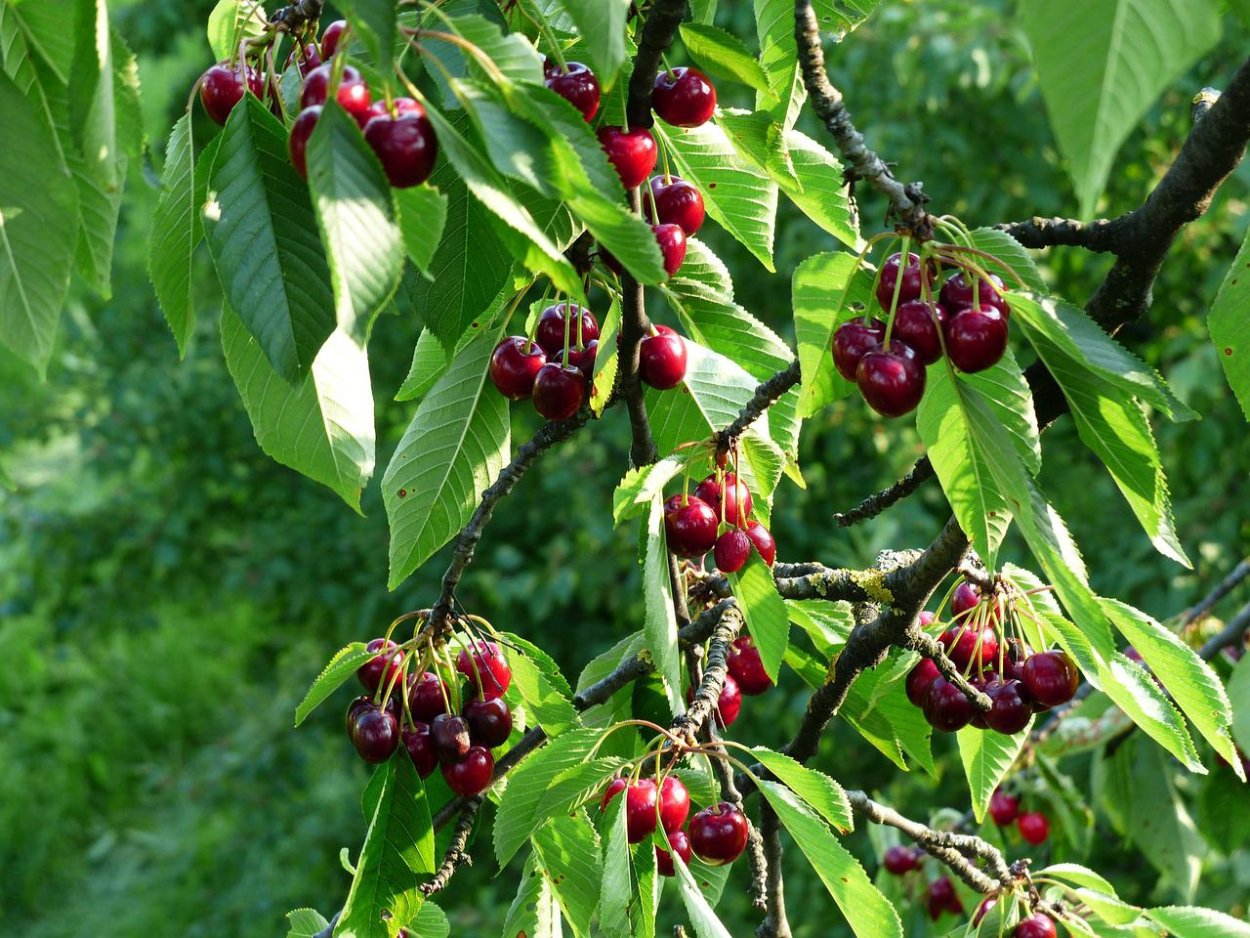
[833,254,1011,416]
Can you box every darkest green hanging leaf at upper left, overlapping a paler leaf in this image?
[205,94,334,383]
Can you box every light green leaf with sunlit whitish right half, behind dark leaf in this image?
[221,306,374,510]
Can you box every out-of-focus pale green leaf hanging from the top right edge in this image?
[1021,0,1220,218]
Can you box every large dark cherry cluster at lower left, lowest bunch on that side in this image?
[348,638,513,797]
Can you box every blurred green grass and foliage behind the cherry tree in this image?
[0,0,1250,938]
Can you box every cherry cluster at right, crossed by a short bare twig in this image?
[906,582,1080,735]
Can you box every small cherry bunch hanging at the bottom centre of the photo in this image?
[599,774,748,877]
